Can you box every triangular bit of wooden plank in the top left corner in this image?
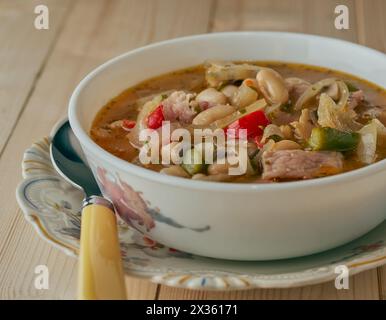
[0,0,70,154]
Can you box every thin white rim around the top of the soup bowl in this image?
[68,31,386,192]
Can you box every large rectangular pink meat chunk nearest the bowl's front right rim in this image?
[262,150,343,180]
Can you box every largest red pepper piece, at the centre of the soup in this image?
[224,110,271,139]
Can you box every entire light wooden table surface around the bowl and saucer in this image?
[0,0,386,299]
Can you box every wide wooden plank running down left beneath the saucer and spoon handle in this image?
[0,0,211,299]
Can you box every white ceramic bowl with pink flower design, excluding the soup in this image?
[69,32,386,260]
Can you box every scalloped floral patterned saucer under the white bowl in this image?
[16,138,386,290]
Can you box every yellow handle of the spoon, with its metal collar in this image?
[78,197,126,300]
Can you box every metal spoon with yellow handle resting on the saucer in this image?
[50,121,126,300]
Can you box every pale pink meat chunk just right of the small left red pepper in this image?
[162,91,197,124]
